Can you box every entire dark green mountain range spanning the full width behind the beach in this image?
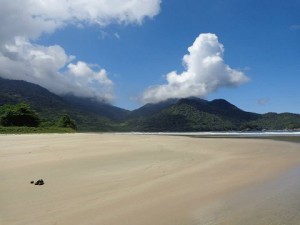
[0,78,300,132]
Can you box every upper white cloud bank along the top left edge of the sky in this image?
[0,0,161,41]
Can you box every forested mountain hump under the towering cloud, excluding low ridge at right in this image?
[128,98,261,131]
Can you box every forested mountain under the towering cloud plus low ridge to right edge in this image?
[127,97,300,132]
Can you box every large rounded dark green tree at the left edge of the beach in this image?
[0,103,40,127]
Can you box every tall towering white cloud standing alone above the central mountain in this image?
[142,33,249,102]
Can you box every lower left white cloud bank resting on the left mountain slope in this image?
[0,39,114,101]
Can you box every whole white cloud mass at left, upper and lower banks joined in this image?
[0,0,161,101]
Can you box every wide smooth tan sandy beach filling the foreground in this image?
[0,134,300,225]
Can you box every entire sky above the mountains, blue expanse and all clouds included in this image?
[0,0,300,113]
